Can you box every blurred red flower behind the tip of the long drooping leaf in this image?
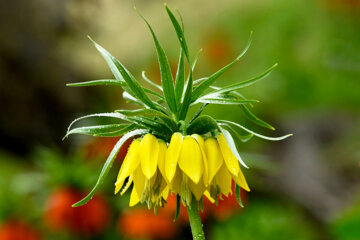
[45,188,110,235]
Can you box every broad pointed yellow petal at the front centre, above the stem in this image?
[179,136,204,184]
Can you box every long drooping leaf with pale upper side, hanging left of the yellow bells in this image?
[72,129,148,207]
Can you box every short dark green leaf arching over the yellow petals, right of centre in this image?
[186,115,219,135]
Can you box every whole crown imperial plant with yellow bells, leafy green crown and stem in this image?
[65,5,290,239]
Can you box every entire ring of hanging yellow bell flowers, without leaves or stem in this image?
[115,132,250,207]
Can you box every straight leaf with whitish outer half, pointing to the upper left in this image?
[89,37,156,108]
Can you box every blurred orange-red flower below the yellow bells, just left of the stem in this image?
[118,209,177,239]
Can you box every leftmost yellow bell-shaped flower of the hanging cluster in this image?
[115,134,169,208]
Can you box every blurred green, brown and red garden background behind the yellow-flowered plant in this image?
[0,0,360,240]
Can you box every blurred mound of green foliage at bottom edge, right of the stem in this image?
[210,200,321,240]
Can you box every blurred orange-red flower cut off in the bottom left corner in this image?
[0,220,41,240]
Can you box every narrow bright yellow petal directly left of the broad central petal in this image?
[165,132,183,182]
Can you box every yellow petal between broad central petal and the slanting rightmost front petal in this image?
[205,138,224,184]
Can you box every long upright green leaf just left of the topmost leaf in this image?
[137,11,177,113]
